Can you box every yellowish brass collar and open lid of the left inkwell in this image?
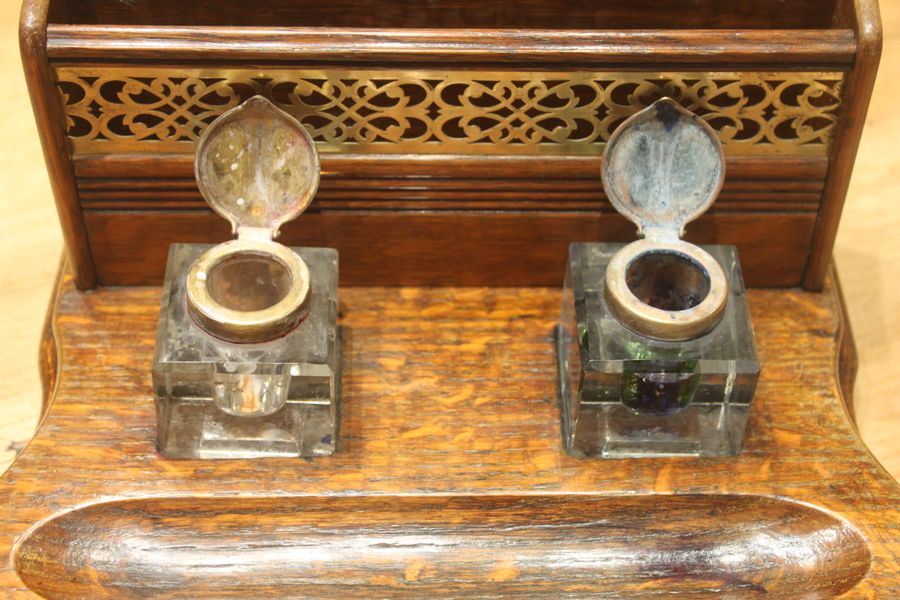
[186,96,319,343]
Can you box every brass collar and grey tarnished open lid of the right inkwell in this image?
[603,98,728,341]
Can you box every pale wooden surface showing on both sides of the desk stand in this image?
[0,0,900,478]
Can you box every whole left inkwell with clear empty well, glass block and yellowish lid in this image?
[153,96,340,458]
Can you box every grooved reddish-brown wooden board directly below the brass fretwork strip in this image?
[68,154,828,286]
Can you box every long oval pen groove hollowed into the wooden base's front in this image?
[10,494,870,599]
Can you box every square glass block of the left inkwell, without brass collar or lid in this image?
[153,244,341,458]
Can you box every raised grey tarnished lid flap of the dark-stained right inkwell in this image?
[603,98,725,240]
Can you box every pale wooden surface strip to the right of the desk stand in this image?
[835,0,900,488]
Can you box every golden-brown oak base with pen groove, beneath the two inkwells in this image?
[0,264,900,598]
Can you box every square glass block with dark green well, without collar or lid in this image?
[557,244,759,458]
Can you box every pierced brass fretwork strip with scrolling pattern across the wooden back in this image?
[56,66,843,155]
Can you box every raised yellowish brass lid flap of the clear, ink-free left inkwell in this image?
[194,96,319,239]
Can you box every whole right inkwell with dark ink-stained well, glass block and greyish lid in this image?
[557,98,759,458]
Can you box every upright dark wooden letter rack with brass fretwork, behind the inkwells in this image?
[21,0,881,290]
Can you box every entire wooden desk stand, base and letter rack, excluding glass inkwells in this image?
[8,0,900,599]
